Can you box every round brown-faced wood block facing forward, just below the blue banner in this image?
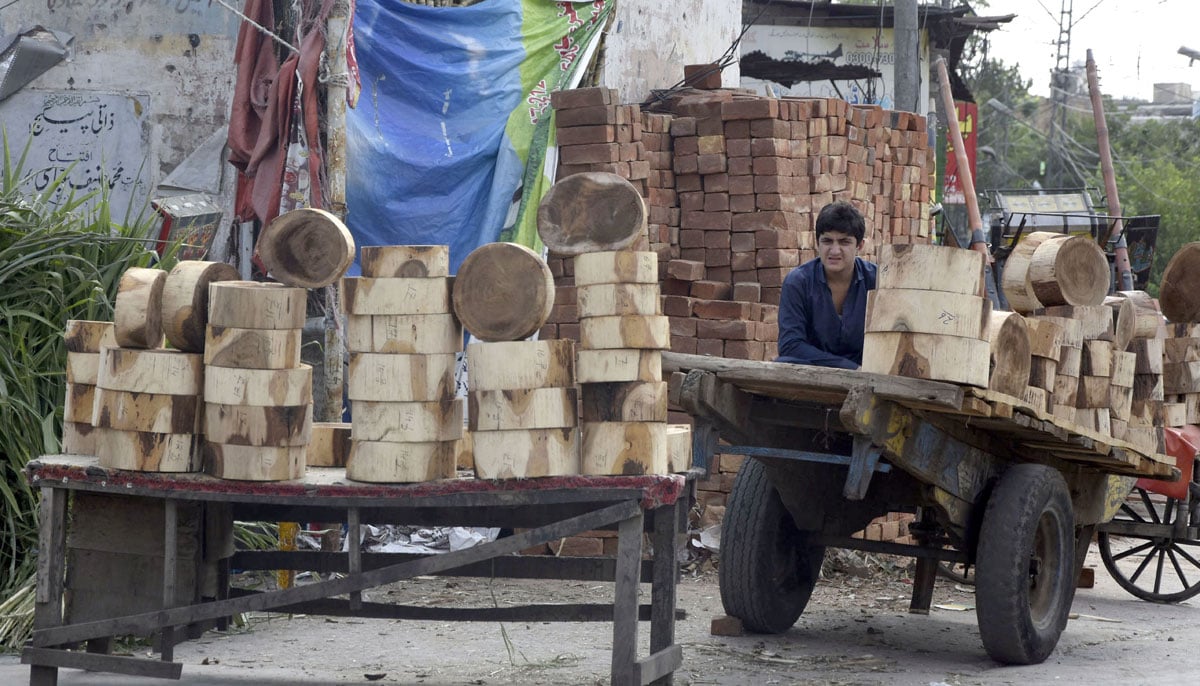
[452,243,554,341]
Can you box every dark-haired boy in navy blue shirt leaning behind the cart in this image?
[775,201,876,369]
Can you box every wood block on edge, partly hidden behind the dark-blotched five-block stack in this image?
[162,260,239,353]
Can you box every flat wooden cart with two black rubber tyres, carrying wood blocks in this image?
[662,354,1180,664]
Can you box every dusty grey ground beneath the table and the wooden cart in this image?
[9,549,1200,686]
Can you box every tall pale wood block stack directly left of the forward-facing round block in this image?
[342,246,463,482]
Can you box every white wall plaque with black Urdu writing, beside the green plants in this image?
[0,90,157,222]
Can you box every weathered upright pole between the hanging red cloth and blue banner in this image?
[318,0,350,422]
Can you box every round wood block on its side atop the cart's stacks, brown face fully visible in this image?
[1030,236,1111,307]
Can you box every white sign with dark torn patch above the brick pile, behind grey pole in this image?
[742,24,930,114]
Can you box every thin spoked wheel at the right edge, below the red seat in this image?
[1097,488,1200,602]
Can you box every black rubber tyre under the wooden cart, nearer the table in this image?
[719,459,824,633]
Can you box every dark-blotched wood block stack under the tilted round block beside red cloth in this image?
[204,281,312,481]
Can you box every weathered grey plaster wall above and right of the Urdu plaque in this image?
[0,0,241,181]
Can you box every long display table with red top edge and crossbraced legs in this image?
[22,456,691,686]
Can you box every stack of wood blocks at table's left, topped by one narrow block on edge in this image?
[92,267,204,471]
